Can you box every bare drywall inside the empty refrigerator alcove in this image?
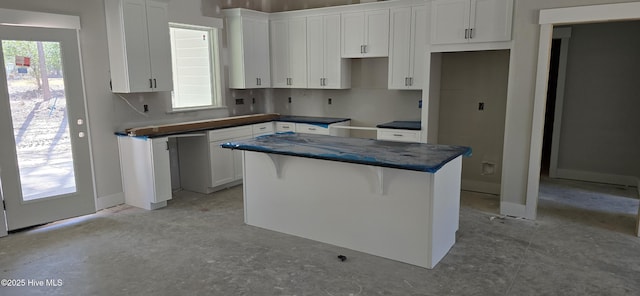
[438,50,509,194]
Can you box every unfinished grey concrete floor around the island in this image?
[0,180,640,296]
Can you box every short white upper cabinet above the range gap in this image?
[342,9,389,58]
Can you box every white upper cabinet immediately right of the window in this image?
[224,8,271,89]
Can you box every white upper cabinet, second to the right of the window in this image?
[269,17,308,88]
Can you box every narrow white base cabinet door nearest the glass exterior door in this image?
[151,138,171,203]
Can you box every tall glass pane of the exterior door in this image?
[2,40,76,201]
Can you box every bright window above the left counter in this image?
[170,24,222,111]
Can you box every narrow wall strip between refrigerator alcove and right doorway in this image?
[501,0,635,218]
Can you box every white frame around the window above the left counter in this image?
[167,22,227,113]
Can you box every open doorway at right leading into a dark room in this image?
[538,22,640,235]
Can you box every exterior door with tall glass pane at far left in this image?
[0,25,95,230]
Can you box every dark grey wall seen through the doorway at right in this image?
[558,21,640,185]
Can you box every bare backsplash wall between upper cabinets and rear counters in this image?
[273,58,422,138]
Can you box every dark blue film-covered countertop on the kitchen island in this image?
[221,133,471,173]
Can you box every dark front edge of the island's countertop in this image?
[220,142,471,174]
